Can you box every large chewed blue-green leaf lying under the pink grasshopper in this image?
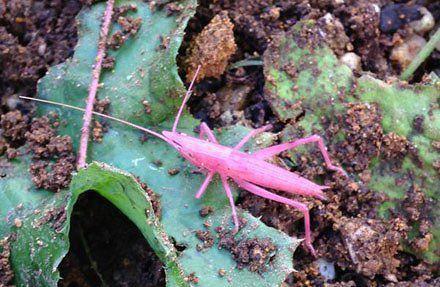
[0,0,300,287]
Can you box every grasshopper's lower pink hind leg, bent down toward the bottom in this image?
[234,179,316,257]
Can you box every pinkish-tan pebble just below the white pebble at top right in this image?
[390,35,426,69]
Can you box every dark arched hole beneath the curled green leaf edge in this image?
[58,192,165,287]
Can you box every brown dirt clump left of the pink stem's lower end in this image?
[25,117,75,192]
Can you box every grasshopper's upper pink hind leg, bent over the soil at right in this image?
[253,135,347,176]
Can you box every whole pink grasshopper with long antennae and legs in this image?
[21,67,345,255]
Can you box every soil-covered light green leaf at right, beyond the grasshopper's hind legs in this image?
[264,21,440,262]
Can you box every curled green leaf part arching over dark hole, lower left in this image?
[0,161,182,286]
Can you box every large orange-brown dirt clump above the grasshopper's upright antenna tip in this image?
[184,13,237,82]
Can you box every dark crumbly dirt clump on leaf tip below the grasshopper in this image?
[218,231,277,273]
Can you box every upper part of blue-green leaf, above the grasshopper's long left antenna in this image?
[38,0,196,147]
